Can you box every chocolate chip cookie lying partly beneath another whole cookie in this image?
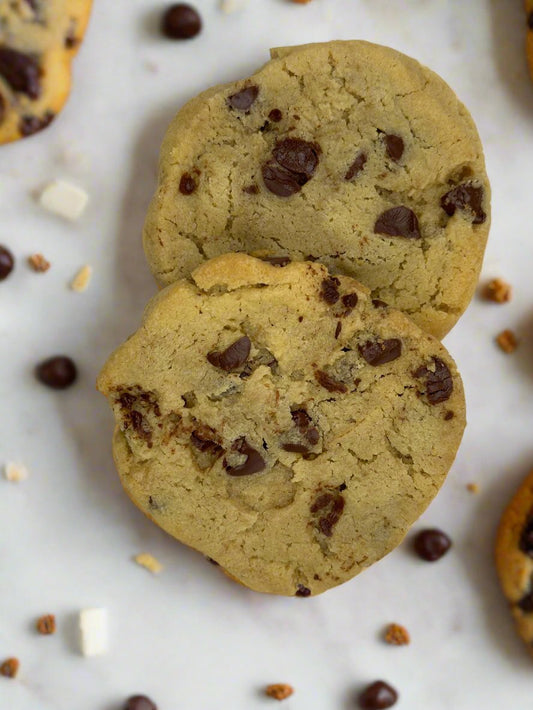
[144,41,490,337]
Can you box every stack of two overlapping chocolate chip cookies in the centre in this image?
[98,42,490,596]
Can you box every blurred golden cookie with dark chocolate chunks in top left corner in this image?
[0,0,92,144]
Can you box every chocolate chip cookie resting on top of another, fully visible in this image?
[98,254,465,596]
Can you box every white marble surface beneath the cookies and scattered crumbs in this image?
[0,0,533,710]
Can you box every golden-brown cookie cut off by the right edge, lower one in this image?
[496,471,533,652]
